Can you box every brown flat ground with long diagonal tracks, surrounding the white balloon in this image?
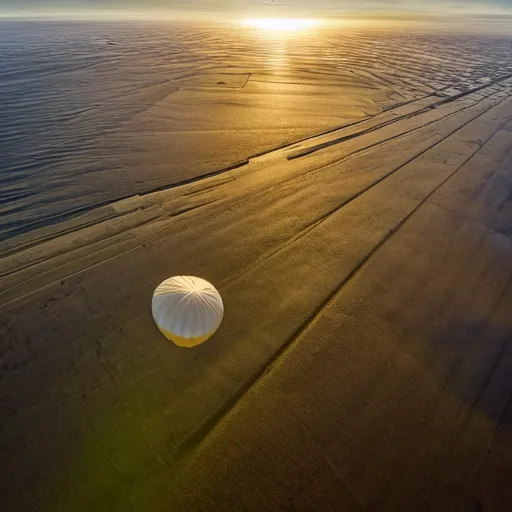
[0,73,512,512]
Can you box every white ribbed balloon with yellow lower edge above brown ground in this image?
[152,276,224,347]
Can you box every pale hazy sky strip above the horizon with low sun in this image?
[0,0,512,18]
